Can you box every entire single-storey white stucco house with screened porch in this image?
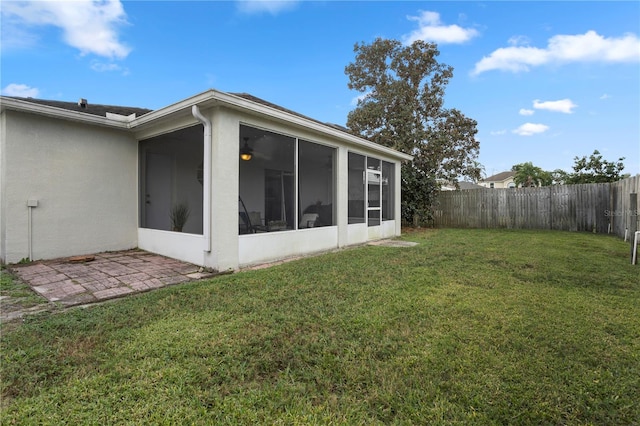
[0,90,412,270]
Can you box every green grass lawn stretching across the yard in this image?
[0,230,640,425]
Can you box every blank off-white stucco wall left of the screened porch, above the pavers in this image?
[0,110,138,263]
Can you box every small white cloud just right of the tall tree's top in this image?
[402,10,480,45]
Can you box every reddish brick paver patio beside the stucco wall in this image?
[11,250,211,306]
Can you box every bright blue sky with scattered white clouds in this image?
[0,0,640,176]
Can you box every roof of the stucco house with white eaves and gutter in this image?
[0,89,413,160]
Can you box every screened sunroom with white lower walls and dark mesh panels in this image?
[138,91,411,270]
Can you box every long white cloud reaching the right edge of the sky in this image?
[472,31,640,75]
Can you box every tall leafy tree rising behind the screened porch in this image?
[345,38,481,222]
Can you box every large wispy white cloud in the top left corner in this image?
[2,0,131,59]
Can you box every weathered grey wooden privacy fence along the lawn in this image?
[434,175,640,238]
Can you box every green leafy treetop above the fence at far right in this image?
[555,149,627,184]
